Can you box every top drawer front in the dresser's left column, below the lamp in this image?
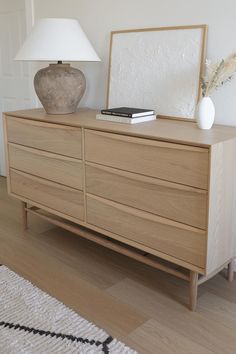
[6,117,82,159]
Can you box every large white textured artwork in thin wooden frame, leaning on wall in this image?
[107,25,207,120]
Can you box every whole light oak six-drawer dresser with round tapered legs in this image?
[4,109,236,310]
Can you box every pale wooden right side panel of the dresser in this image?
[206,140,236,274]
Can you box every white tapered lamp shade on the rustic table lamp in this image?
[15,18,100,61]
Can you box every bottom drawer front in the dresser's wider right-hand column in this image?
[87,195,206,268]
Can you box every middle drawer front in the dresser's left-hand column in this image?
[8,144,83,190]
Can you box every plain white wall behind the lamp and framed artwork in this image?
[34,0,236,125]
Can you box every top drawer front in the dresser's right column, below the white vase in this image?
[85,130,209,189]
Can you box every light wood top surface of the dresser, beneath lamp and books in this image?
[5,108,236,147]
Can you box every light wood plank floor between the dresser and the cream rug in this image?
[0,177,236,354]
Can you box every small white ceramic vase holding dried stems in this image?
[197,97,215,129]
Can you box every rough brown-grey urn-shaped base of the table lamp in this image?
[34,64,86,114]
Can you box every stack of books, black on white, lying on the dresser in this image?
[96,107,156,124]
